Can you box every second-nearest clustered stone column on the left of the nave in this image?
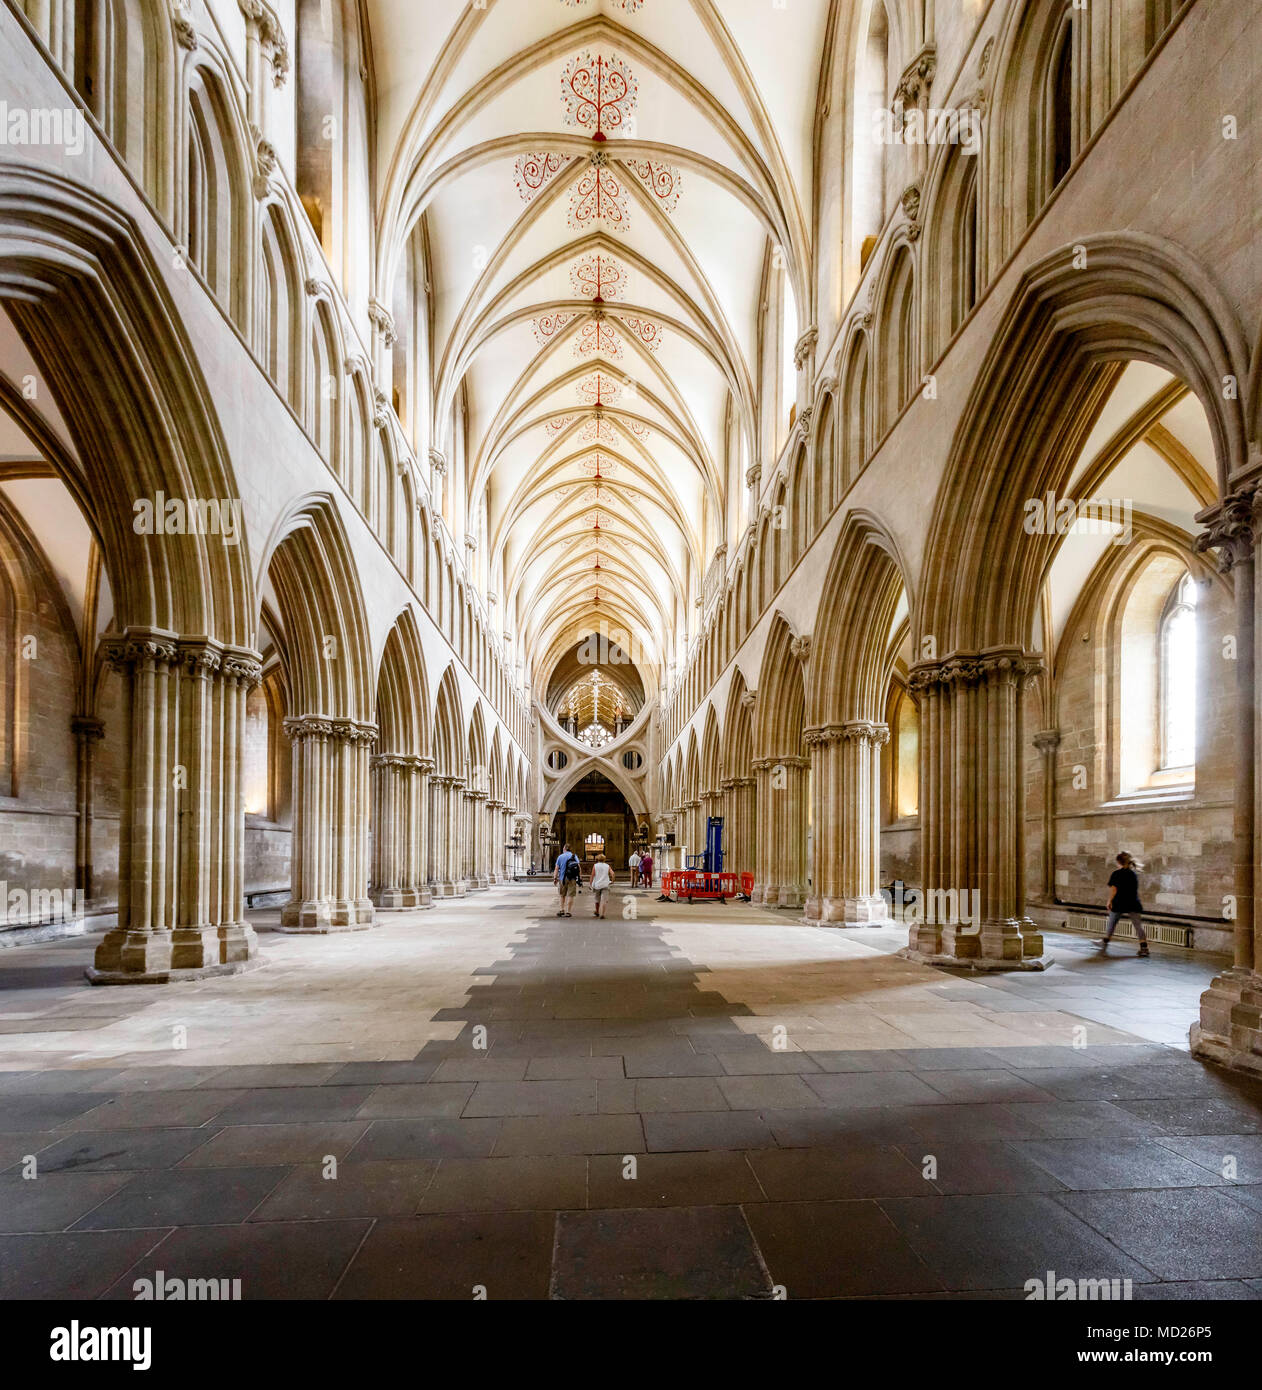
[281,714,377,933]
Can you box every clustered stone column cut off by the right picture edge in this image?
[1190,482,1262,1072]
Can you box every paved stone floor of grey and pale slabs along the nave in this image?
[0,888,1262,1300]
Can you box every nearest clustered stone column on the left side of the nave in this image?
[88,628,261,984]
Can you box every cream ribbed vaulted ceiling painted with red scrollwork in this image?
[368,0,830,688]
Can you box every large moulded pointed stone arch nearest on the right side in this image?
[917,234,1247,656]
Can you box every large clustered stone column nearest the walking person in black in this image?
[902,648,1048,970]
